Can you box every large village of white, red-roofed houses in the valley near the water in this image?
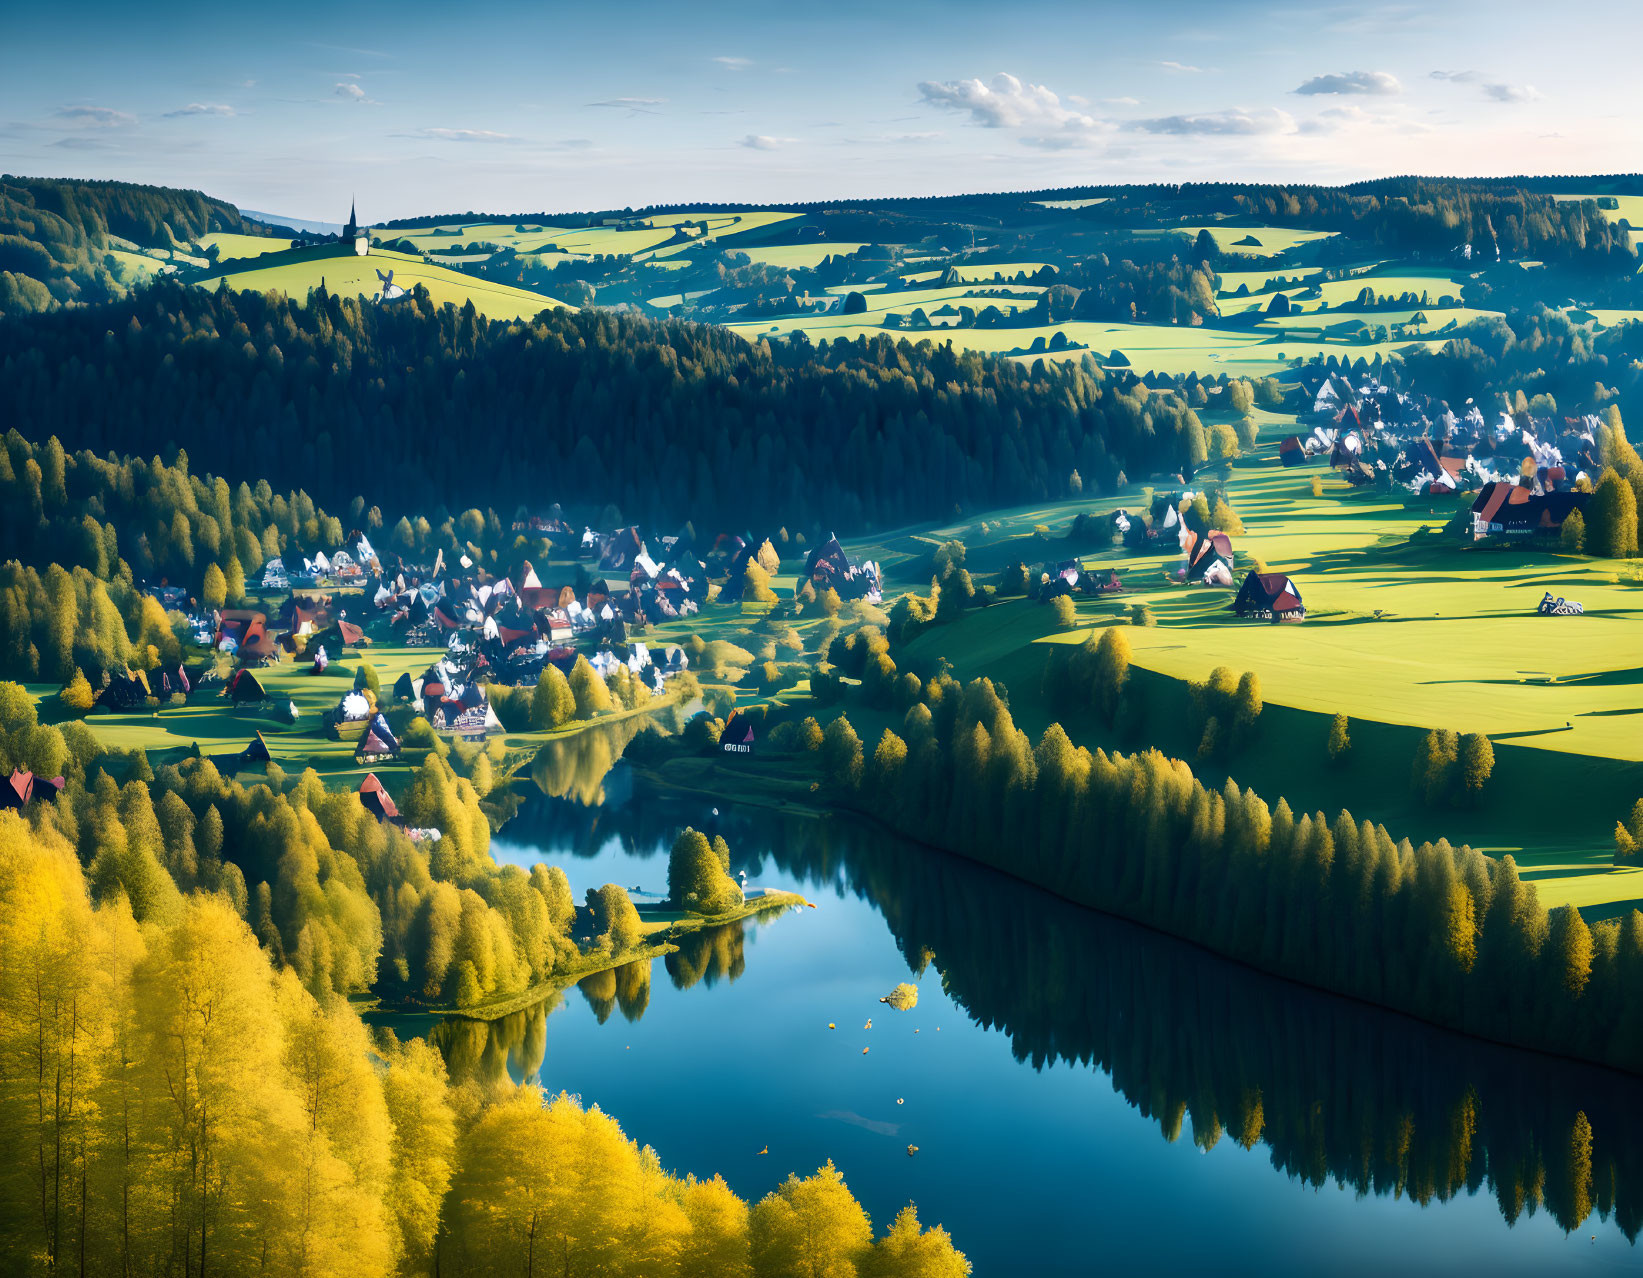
[22,506,882,841]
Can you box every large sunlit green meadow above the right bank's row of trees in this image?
[851,411,1643,917]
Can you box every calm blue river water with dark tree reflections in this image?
[369,764,1643,1275]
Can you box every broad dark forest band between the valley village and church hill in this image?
[0,281,1208,529]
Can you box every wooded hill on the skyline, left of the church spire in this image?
[0,174,266,315]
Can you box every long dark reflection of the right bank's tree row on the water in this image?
[519,775,1643,1239]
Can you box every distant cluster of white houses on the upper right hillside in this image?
[1278,373,1599,539]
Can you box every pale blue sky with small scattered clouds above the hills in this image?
[0,0,1643,222]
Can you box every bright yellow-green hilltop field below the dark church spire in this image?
[200,246,565,319]
